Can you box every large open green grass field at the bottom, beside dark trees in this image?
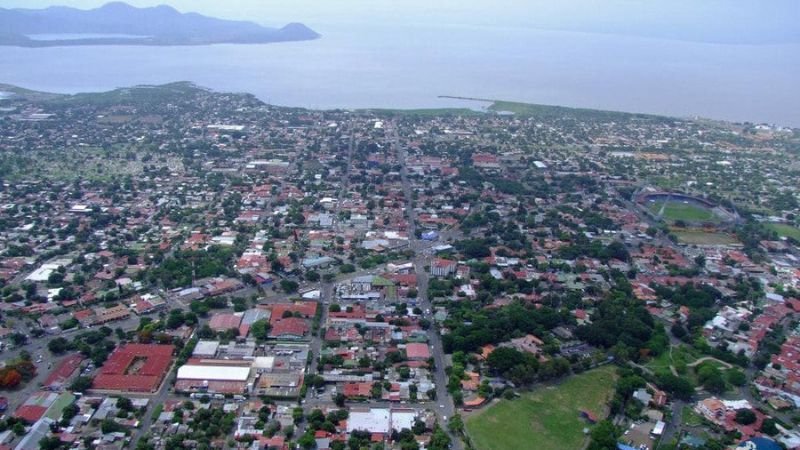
[466,366,616,450]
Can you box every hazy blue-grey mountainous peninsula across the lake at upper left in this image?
[0,2,320,47]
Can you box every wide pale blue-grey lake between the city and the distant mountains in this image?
[0,24,800,126]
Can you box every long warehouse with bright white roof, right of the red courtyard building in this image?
[175,360,252,394]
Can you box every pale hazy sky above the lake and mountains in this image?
[0,0,800,44]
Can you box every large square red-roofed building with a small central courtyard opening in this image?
[92,344,175,392]
